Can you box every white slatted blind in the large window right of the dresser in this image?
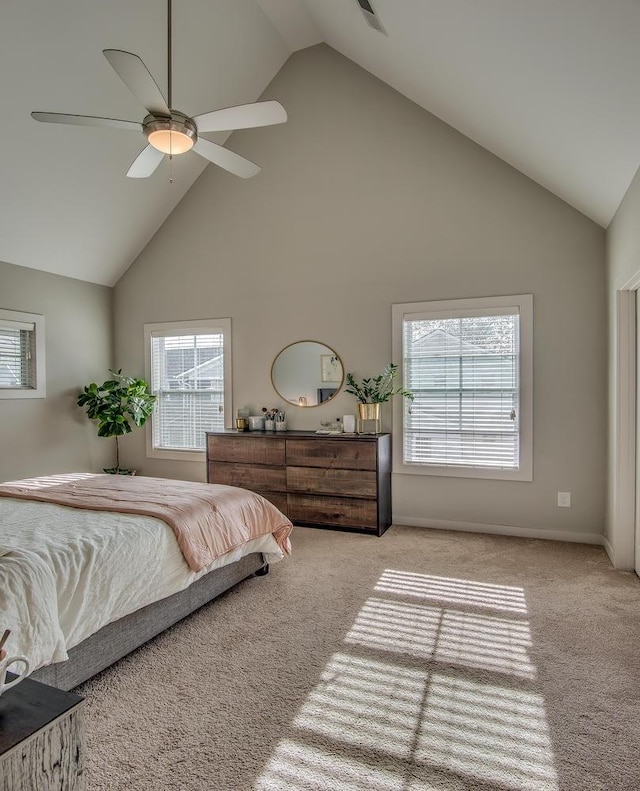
[403,308,520,469]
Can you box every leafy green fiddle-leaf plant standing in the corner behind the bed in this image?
[77,369,156,475]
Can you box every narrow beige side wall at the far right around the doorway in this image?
[605,162,640,568]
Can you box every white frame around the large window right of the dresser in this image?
[392,294,533,481]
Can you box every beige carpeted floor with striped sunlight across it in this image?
[77,526,640,791]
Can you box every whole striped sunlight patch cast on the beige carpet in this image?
[254,569,559,791]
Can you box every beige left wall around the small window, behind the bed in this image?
[0,262,113,481]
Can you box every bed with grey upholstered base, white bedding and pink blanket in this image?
[0,473,292,689]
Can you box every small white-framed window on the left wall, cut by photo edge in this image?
[0,310,47,398]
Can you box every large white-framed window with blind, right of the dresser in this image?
[393,294,533,481]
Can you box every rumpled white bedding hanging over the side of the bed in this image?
[0,497,283,671]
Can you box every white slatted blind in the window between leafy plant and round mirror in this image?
[151,330,225,450]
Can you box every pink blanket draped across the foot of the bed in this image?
[0,473,293,571]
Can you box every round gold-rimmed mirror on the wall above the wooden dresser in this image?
[271,341,344,406]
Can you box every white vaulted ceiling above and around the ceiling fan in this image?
[0,0,640,285]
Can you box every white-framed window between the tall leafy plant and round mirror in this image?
[145,319,231,460]
